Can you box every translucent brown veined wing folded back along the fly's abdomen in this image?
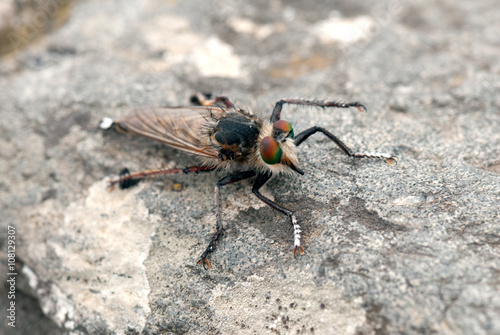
[116,106,224,158]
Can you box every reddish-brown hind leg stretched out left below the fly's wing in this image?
[108,166,215,191]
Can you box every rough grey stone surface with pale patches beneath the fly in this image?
[0,0,500,334]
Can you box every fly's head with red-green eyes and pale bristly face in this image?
[259,120,304,174]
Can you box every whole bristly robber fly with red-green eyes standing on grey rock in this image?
[100,93,396,268]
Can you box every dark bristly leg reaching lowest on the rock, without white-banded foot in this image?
[198,171,255,269]
